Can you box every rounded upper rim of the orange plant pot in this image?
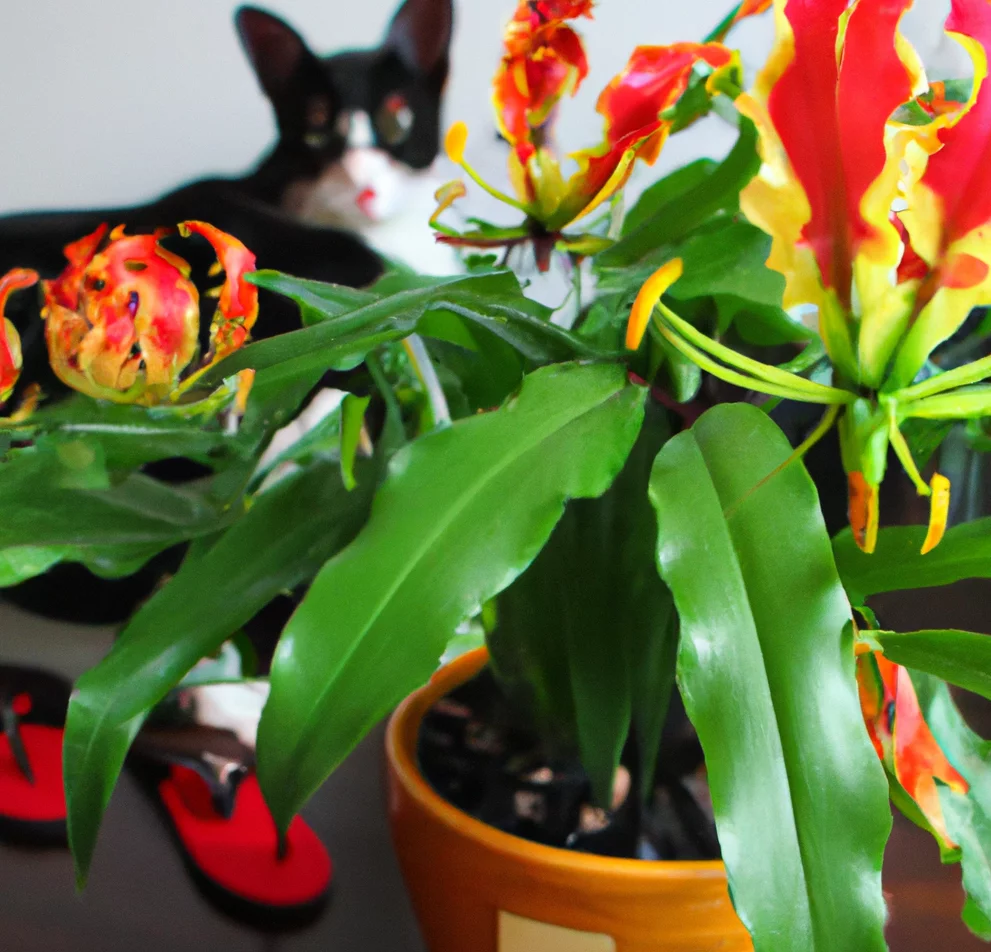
[385,647,726,881]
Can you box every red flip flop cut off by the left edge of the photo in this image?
[0,665,71,846]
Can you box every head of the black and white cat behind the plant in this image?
[236,0,456,274]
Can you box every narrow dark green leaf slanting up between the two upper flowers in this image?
[595,119,760,268]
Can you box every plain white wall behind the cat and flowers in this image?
[0,0,949,212]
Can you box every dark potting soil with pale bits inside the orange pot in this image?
[417,669,719,860]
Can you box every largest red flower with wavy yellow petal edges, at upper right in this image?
[631,0,991,551]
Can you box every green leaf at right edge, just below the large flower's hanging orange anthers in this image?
[833,518,991,605]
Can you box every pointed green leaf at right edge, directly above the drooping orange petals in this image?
[871,629,991,698]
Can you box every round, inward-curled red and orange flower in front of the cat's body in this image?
[37,222,258,405]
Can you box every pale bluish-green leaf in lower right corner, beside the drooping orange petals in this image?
[912,672,991,939]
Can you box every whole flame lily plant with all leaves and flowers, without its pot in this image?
[13,0,991,952]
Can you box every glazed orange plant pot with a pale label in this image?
[386,648,753,952]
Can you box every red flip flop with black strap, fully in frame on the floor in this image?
[133,725,333,924]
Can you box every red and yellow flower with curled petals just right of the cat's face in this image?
[434,0,739,270]
